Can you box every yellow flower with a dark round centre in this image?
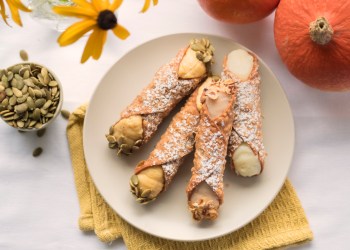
[54,0,130,63]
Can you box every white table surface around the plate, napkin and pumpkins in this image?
[0,0,350,250]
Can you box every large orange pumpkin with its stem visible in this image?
[274,0,350,91]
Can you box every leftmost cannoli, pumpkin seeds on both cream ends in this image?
[106,39,214,154]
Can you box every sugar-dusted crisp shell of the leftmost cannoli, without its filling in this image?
[121,46,205,145]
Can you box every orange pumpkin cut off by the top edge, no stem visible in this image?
[198,0,279,23]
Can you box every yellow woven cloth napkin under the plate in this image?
[67,105,313,250]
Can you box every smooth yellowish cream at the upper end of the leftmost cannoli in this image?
[178,48,207,79]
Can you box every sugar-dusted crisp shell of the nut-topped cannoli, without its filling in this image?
[186,83,235,204]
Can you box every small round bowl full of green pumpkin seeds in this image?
[0,62,63,131]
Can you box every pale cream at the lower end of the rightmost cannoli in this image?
[232,143,261,177]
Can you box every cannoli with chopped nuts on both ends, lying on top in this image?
[186,80,235,221]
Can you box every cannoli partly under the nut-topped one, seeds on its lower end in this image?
[130,77,212,204]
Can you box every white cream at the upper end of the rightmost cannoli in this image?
[227,49,254,81]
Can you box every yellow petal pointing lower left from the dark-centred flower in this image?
[57,20,97,46]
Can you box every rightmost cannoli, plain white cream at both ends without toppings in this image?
[222,49,266,176]
